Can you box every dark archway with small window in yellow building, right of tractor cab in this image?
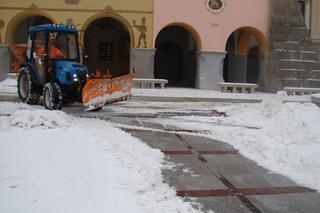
[84,17,131,77]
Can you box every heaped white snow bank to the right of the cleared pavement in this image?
[168,94,320,191]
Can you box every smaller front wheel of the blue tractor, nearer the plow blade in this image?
[43,82,62,110]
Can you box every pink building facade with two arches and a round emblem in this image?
[147,0,269,89]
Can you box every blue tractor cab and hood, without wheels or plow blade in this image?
[26,24,88,86]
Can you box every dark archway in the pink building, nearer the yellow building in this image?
[154,25,197,87]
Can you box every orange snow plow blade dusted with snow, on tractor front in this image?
[82,73,134,111]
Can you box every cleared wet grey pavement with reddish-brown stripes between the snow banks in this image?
[65,100,320,213]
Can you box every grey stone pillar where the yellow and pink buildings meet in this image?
[130,48,156,78]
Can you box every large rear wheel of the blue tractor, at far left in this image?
[18,67,40,104]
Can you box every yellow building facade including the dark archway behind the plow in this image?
[0,0,153,78]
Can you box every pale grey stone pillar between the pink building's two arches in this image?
[195,51,226,90]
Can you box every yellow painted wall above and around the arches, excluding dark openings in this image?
[0,0,153,47]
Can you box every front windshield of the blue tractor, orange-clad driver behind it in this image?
[48,32,78,60]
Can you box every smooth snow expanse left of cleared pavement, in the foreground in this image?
[0,102,197,213]
